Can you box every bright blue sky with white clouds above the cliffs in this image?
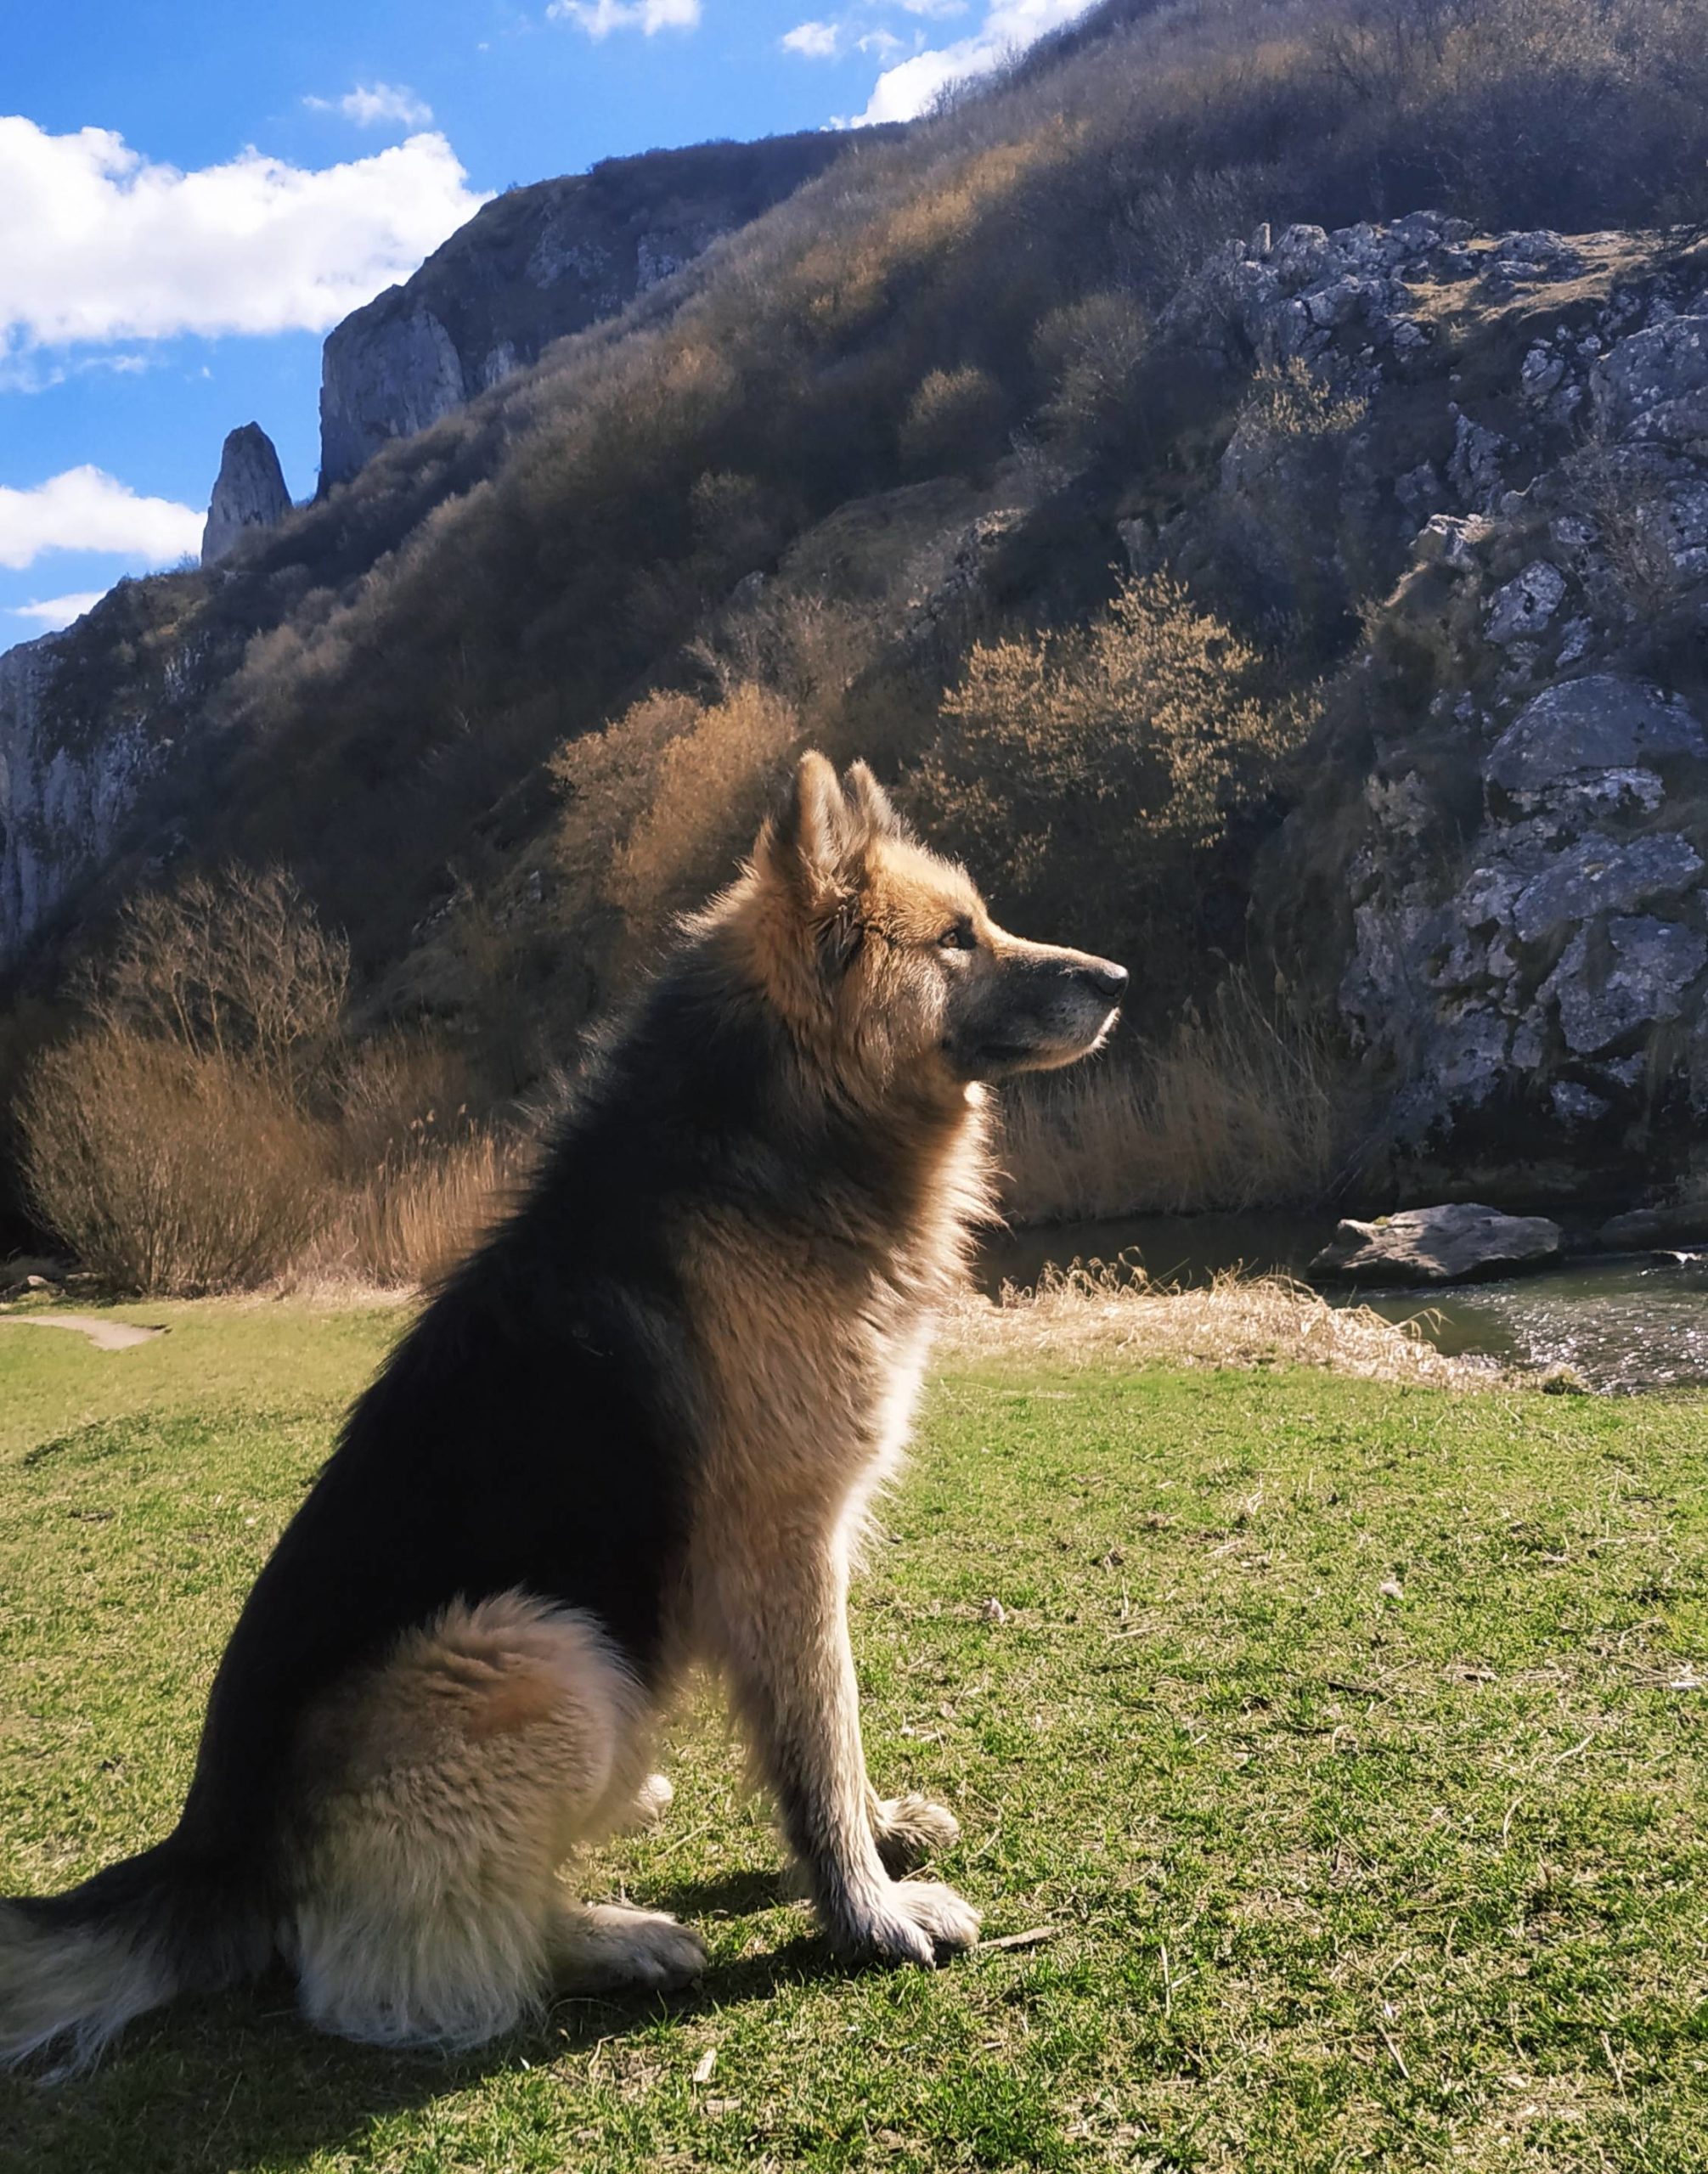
[0,0,1091,648]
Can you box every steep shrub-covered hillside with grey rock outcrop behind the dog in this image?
[0,0,1708,1260]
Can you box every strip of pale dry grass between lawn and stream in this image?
[945,1259,1503,1389]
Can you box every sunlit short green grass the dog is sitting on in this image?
[0,1304,1708,2174]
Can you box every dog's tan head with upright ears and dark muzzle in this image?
[728,754,1128,1100]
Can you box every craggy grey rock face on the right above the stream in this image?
[1181,215,1708,1187]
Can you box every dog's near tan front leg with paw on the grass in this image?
[719,1544,978,1963]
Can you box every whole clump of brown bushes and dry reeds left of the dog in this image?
[17,870,519,1296]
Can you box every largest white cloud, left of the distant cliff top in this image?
[0,115,482,357]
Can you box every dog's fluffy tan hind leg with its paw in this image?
[291,1593,682,2048]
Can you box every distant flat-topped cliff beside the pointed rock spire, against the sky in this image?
[319,131,865,489]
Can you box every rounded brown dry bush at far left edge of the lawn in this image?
[20,1026,332,1298]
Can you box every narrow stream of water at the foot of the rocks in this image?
[982,1215,1708,1394]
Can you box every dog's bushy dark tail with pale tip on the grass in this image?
[0,1835,273,2074]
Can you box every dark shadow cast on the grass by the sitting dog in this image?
[0,1870,837,2174]
